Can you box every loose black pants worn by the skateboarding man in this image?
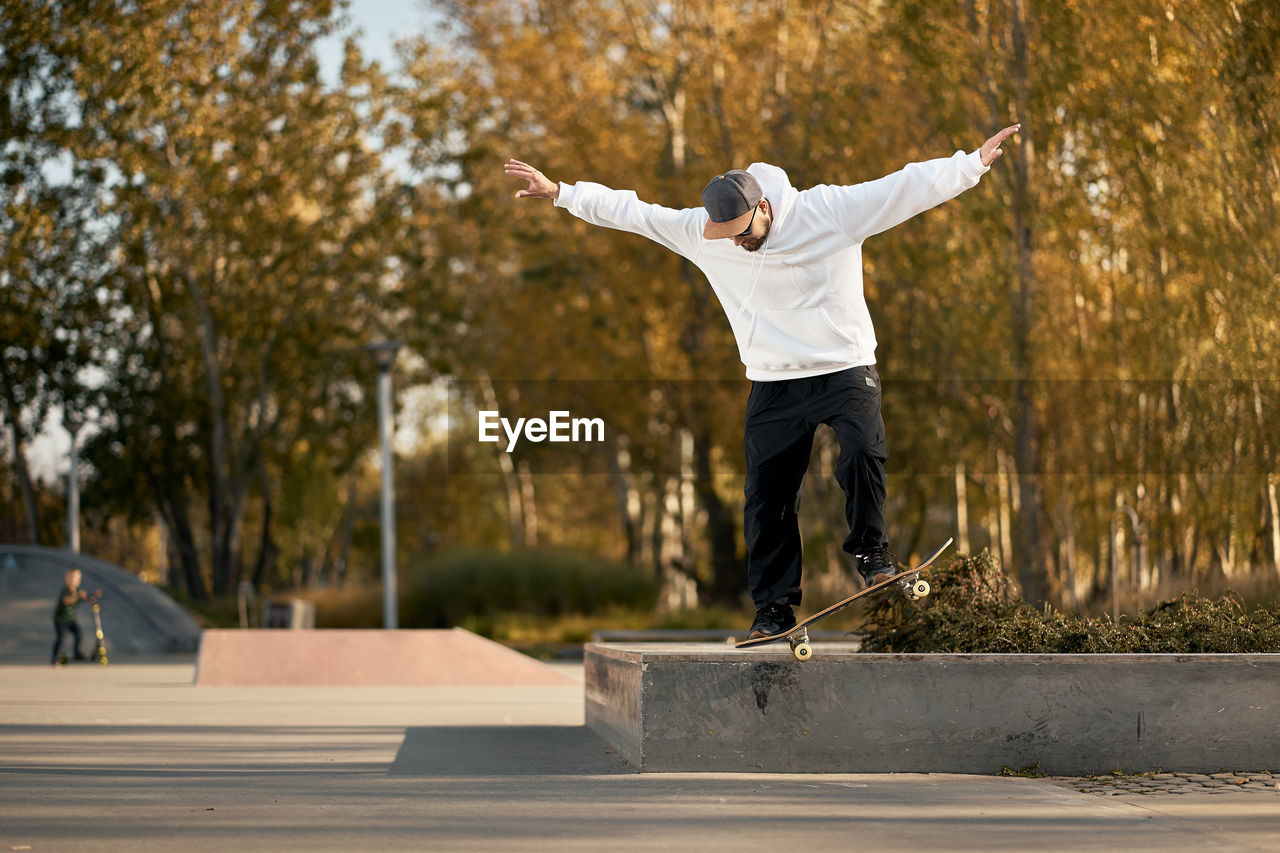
[742,366,888,607]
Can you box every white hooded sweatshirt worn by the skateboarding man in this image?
[556,151,988,382]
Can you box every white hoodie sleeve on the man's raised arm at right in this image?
[808,151,991,243]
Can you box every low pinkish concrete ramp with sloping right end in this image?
[196,628,573,686]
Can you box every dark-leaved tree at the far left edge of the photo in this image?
[0,0,111,544]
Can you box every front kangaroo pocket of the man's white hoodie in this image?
[742,307,859,370]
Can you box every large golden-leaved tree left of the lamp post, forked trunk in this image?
[11,0,402,596]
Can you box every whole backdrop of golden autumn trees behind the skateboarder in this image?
[0,0,1280,608]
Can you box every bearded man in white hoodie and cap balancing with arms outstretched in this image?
[504,124,1021,638]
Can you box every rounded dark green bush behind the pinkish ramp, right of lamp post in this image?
[401,549,658,635]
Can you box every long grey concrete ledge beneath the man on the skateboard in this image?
[585,643,1280,775]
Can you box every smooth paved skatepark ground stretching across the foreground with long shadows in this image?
[0,660,1280,853]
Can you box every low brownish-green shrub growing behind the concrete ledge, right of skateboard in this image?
[863,551,1280,653]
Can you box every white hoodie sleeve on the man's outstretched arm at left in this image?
[556,181,707,260]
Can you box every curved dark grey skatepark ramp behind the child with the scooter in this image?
[0,544,200,662]
